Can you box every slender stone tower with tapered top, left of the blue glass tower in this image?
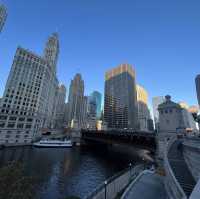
[68,73,87,128]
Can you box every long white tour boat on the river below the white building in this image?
[33,140,72,147]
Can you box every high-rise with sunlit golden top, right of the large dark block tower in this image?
[136,84,151,131]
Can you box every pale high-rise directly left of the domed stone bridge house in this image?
[152,96,165,130]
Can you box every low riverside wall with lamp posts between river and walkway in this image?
[84,165,144,199]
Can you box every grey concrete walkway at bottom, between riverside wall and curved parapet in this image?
[123,173,167,199]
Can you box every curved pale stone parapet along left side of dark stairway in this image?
[164,136,187,199]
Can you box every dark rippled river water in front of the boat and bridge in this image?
[0,147,150,199]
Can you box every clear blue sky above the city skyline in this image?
[0,0,200,108]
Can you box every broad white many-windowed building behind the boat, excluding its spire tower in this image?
[0,32,58,145]
